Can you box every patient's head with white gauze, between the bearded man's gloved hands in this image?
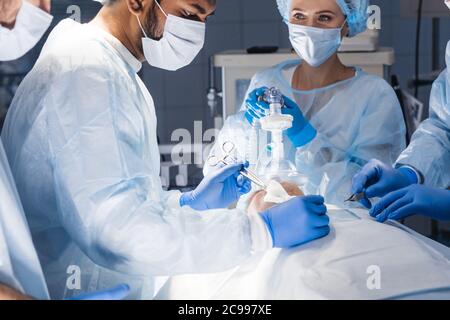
[247,180,304,214]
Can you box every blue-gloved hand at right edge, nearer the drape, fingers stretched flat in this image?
[369,184,450,222]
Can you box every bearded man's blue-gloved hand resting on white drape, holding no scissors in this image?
[261,196,330,248]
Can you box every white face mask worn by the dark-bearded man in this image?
[138,1,206,71]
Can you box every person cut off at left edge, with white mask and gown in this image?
[0,1,52,299]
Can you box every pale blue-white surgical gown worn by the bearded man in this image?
[2,19,252,298]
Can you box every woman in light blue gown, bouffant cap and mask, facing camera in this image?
[204,0,405,205]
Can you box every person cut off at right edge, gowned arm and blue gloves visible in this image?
[353,1,450,222]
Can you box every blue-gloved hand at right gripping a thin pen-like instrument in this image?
[352,159,418,209]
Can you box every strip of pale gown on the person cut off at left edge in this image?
[0,142,49,299]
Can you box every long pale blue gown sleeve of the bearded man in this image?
[45,66,255,275]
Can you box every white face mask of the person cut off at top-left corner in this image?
[0,1,53,61]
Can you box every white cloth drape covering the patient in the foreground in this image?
[157,182,450,299]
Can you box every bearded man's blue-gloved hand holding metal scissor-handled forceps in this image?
[180,162,251,210]
